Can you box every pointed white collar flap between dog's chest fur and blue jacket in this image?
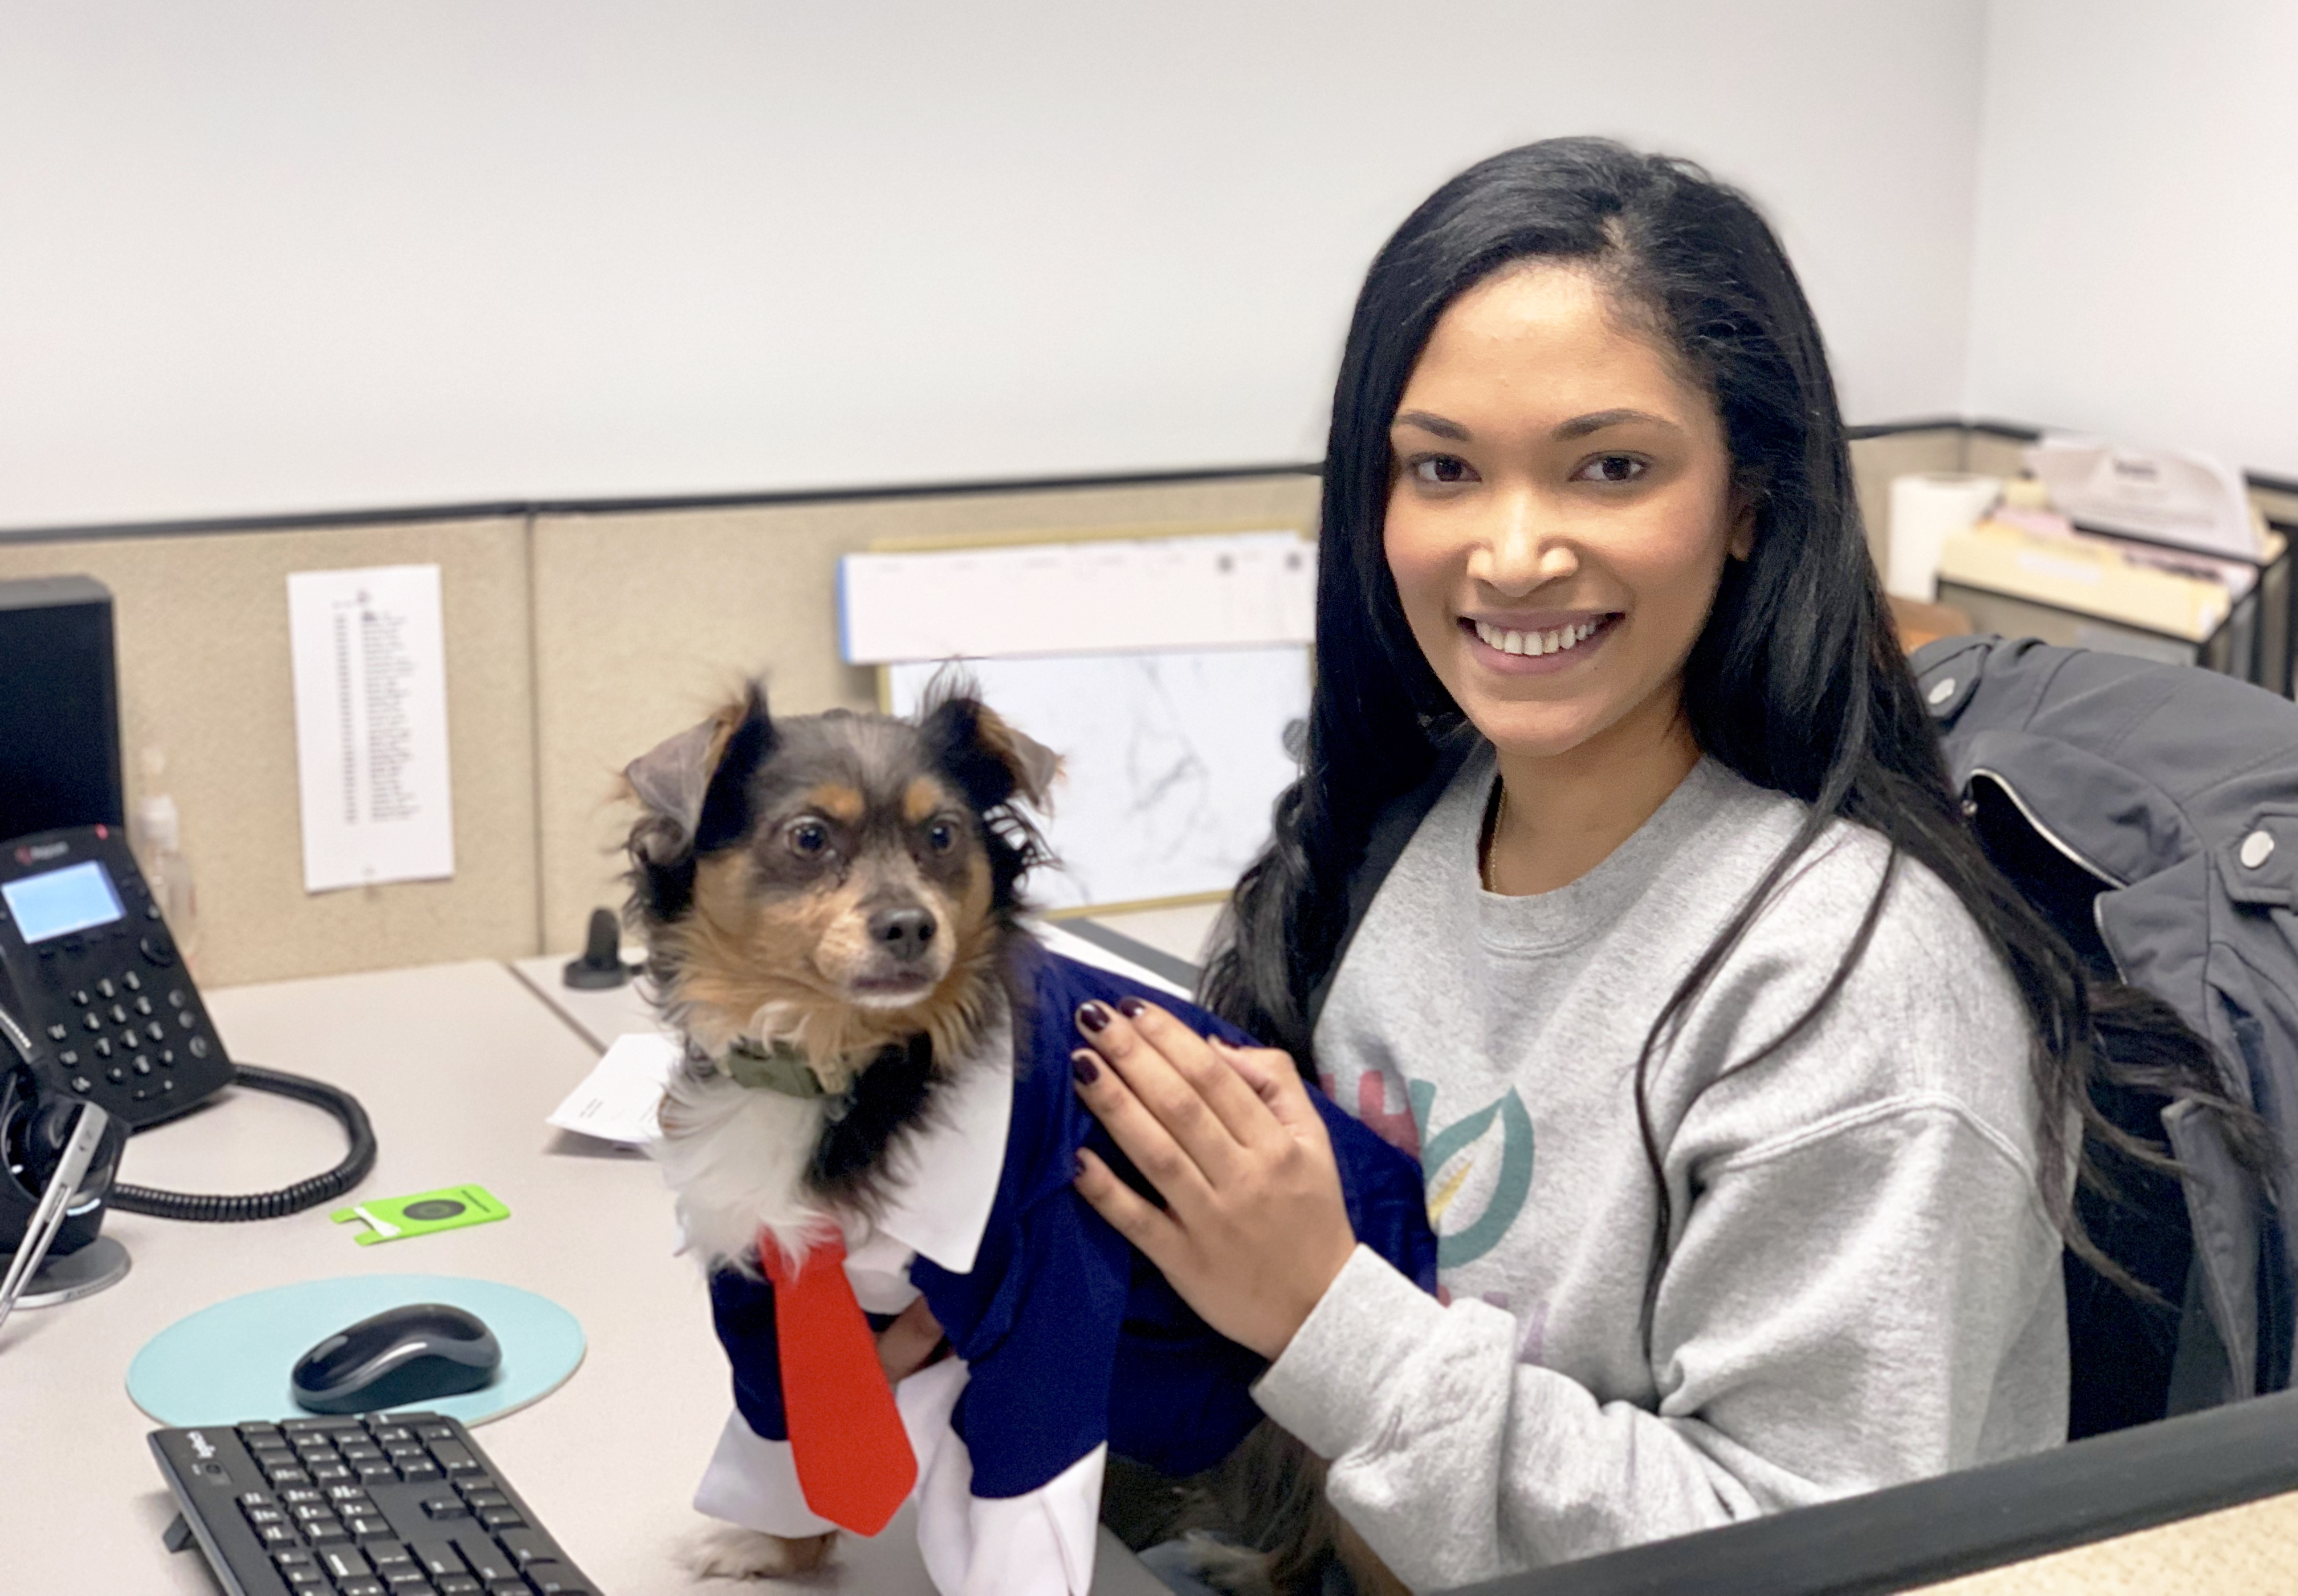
[875,994,1013,1274]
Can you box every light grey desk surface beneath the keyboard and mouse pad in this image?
[0,963,1163,1596]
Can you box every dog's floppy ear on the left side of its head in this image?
[623,683,775,920]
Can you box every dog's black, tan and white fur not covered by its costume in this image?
[628,683,1402,1596]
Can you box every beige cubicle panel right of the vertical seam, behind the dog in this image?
[533,474,1317,952]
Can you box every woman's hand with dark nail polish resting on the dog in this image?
[1071,998,1356,1359]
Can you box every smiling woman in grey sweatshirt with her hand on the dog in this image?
[1078,140,2234,1589]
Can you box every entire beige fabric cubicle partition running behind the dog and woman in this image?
[0,432,2298,984]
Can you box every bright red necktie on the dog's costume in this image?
[759,1235,917,1534]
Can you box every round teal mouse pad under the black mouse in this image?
[129,1274,584,1428]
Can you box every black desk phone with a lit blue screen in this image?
[0,825,234,1129]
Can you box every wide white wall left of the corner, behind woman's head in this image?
[0,0,1983,527]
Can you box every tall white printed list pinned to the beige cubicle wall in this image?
[287,566,455,892]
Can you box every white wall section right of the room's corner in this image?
[1967,0,2298,476]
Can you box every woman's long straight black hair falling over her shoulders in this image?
[1202,138,2256,1322]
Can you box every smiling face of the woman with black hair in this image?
[1383,264,1753,777]
